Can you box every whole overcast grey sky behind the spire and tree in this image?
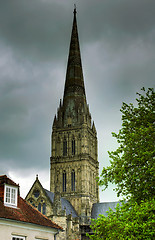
[0,0,155,201]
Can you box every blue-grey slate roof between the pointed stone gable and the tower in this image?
[44,189,78,217]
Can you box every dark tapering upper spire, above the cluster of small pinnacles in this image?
[64,5,85,99]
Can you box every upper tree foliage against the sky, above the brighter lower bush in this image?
[99,88,155,202]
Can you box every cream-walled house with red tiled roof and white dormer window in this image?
[0,175,63,240]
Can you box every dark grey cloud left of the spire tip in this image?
[0,0,69,61]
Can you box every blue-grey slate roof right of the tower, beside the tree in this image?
[91,202,120,219]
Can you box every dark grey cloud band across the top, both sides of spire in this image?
[0,0,155,61]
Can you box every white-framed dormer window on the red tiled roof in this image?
[4,184,18,207]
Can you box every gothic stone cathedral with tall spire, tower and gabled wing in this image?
[26,9,100,240]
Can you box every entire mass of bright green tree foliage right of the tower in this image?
[90,88,155,240]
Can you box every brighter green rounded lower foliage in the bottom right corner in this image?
[90,200,155,240]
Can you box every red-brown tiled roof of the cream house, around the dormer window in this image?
[0,175,63,230]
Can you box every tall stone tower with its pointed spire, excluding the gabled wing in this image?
[50,9,99,224]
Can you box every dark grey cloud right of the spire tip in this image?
[81,0,155,41]
